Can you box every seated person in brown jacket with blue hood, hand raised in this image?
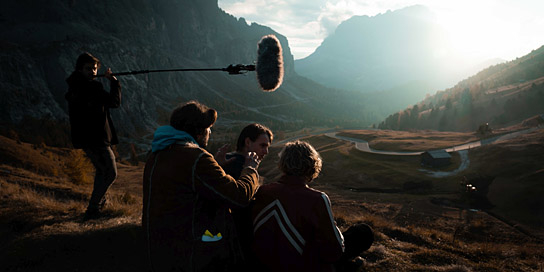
[142,101,260,271]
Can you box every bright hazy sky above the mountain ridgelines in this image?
[219,0,544,60]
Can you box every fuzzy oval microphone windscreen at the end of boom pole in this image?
[255,35,283,92]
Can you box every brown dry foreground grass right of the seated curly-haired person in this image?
[335,203,544,271]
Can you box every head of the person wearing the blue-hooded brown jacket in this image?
[170,101,217,148]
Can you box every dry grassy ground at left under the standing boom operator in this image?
[0,165,145,271]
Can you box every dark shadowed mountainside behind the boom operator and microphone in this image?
[0,0,373,154]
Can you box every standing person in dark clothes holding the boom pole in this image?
[65,52,121,219]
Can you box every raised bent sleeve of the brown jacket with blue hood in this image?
[192,152,259,208]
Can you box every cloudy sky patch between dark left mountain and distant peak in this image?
[219,0,418,58]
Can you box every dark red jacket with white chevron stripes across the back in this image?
[252,176,344,272]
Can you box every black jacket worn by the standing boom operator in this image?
[65,71,121,148]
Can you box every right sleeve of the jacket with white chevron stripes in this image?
[315,193,344,263]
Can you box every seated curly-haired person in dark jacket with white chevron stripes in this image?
[252,141,374,272]
